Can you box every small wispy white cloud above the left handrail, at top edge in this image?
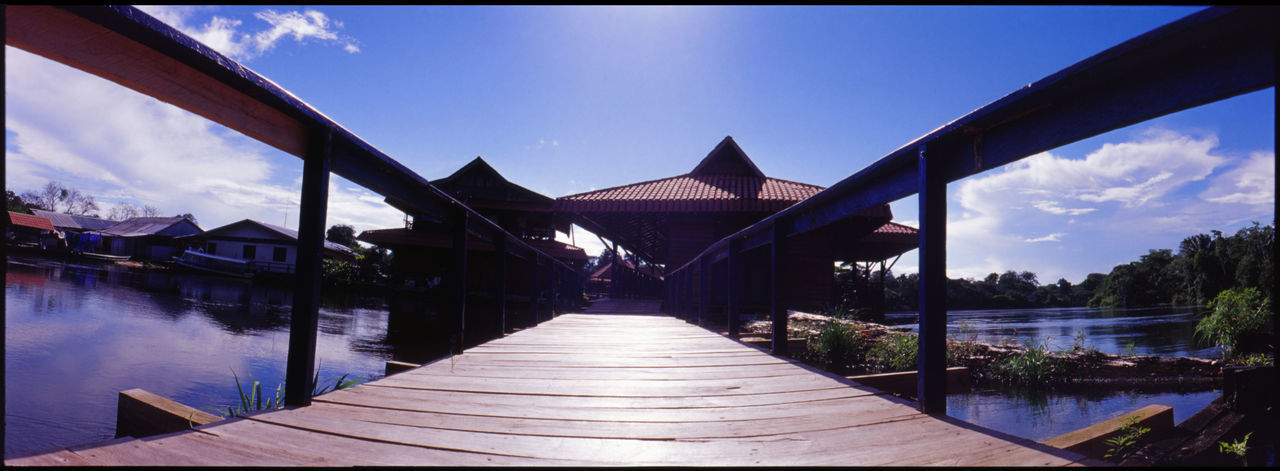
[138,6,360,61]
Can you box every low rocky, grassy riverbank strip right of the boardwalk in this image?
[742,312,1224,389]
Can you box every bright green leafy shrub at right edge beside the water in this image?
[1196,288,1271,358]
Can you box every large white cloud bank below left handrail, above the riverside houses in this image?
[5,47,402,230]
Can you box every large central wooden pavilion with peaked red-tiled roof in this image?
[556,137,916,310]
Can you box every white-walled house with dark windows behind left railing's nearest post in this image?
[183,219,356,273]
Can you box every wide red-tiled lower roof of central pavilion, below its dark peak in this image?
[556,174,823,212]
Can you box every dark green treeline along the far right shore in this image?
[884,223,1275,311]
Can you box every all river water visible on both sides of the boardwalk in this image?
[4,256,1220,457]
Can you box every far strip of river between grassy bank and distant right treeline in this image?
[886,307,1220,358]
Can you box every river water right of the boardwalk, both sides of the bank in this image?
[884,307,1222,440]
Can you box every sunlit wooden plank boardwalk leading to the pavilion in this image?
[5,299,1093,466]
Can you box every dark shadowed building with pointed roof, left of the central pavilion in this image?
[357,157,588,293]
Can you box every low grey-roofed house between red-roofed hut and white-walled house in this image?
[97,218,204,260]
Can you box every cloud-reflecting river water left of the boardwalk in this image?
[5,257,448,457]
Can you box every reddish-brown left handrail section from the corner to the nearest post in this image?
[5,5,307,157]
